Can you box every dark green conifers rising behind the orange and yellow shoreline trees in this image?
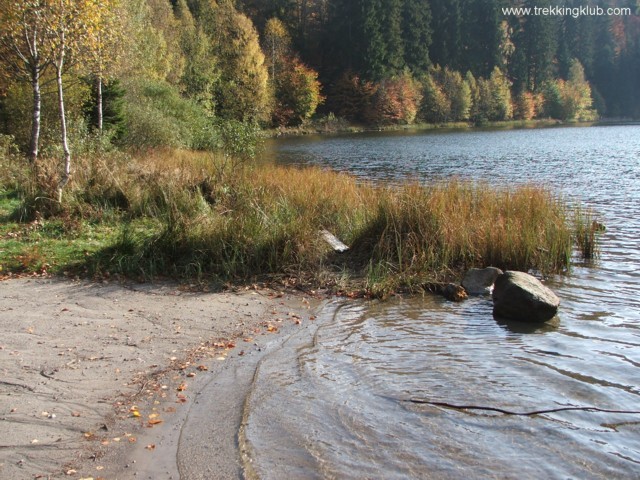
[238,0,640,117]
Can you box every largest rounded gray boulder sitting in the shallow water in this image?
[493,271,560,322]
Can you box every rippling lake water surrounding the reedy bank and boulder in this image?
[241,126,640,479]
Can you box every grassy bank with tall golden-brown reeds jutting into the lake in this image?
[0,151,596,295]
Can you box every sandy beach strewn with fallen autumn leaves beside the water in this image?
[0,278,320,479]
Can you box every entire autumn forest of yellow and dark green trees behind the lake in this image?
[0,0,640,177]
